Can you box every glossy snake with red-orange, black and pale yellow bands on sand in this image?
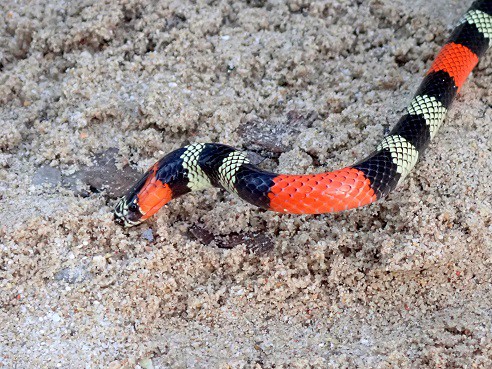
[113,0,492,227]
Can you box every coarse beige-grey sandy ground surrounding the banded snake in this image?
[0,0,492,369]
